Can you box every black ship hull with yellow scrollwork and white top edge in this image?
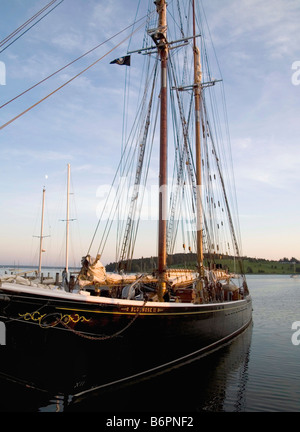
[0,285,252,392]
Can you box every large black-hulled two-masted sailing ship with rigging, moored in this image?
[0,0,252,386]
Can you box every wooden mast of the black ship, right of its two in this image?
[193,0,203,274]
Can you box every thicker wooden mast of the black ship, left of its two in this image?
[152,0,168,301]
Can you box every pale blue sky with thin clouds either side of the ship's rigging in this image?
[0,0,300,265]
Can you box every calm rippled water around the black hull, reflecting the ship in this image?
[0,276,300,412]
